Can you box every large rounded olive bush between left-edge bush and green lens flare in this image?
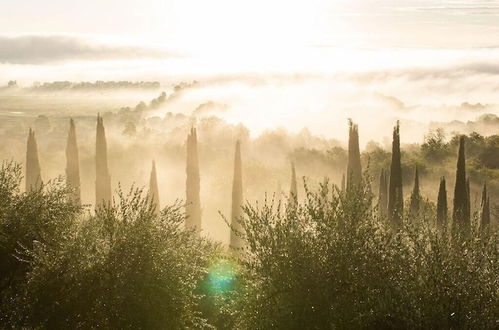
[15,187,216,329]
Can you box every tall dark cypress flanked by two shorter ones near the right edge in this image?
[452,136,471,231]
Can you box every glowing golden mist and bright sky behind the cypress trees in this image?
[0,0,499,239]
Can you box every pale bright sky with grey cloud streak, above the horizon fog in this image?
[0,0,499,80]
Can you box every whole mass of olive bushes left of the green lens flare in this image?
[0,167,216,329]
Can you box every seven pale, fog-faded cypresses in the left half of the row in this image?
[26,115,254,248]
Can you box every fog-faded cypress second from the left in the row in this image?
[66,118,81,204]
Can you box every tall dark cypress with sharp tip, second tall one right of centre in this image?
[388,121,404,228]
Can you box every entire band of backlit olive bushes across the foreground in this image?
[0,163,499,329]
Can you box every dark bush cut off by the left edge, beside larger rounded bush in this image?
[0,162,82,326]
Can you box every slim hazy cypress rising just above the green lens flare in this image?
[230,141,244,249]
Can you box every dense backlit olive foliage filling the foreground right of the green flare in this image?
[238,184,499,329]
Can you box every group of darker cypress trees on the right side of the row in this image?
[342,120,490,233]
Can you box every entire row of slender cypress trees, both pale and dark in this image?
[26,115,490,248]
